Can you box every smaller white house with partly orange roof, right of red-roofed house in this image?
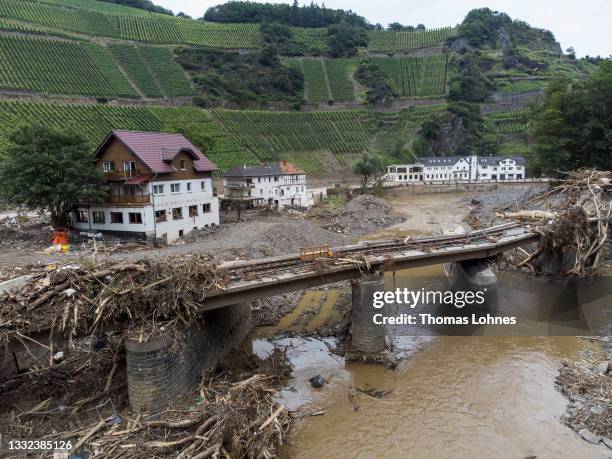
[223,161,313,209]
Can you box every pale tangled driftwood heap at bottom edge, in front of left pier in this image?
[57,374,291,459]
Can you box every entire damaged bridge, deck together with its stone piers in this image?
[0,222,540,412]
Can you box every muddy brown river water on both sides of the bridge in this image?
[260,190,610,458]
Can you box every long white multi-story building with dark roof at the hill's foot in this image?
[383,155,526,183]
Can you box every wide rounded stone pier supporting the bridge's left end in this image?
[125,303,251,413]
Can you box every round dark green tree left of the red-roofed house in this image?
[0,125,106,228]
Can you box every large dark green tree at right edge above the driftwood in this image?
[530,61,612,175]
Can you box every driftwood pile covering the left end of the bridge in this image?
[0,255,227,345]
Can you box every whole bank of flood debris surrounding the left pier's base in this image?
[0,349,292,458]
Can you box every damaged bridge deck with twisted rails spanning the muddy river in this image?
[202,223,540,310]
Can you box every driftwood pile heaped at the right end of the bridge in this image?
[497,169,612,275]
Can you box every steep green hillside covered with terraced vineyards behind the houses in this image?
[0,0,596,175]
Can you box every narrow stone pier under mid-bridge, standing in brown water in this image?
[345,276,386,363]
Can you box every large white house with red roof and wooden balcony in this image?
[73,131,219,242]
